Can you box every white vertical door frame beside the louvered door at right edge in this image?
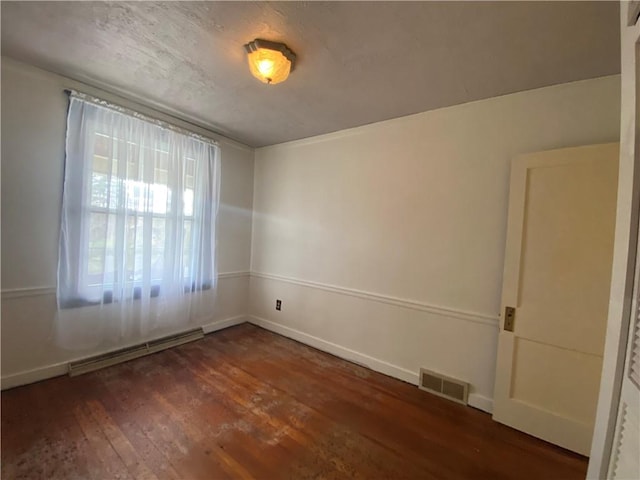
[587,5,640,480]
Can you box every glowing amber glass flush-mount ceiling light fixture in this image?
[244,38,296,85]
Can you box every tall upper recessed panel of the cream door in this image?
[518,159,617,355]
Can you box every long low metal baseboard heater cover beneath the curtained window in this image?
[69,328,204,377]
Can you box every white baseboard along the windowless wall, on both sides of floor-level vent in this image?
[247,315,493,413]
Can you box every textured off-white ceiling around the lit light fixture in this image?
[1,1,620,147]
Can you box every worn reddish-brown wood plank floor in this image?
[0,324,587,480]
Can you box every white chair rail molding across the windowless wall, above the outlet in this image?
[251,272,500,328]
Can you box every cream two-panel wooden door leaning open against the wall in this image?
[493,144,618,455]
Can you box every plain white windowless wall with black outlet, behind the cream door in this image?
[250,76,620,410]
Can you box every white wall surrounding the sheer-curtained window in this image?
[1,57,254,388]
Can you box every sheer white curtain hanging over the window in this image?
[56,92,220,348]
